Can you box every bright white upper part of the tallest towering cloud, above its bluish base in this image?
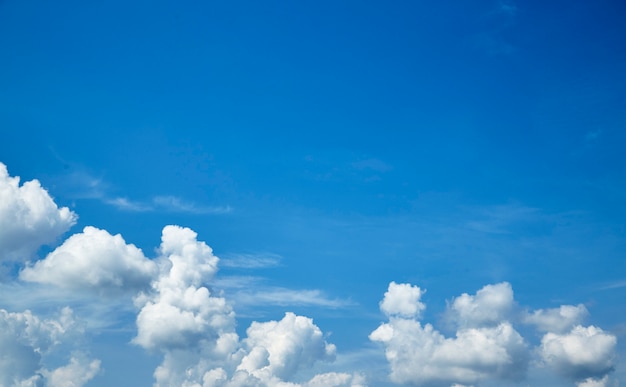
[133,226,234,350]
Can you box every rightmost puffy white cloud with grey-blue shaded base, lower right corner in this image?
[540,325,617,383]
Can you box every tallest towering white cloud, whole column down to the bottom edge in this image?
[133,226,239,386]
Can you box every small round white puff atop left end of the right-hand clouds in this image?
[380,282,426,317]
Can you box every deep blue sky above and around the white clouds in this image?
[0,1,626,385]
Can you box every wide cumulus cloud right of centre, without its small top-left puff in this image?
[370,284,529,385]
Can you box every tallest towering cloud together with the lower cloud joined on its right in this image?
[133,226,353,386]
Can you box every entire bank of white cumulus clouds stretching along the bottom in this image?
[0,164,617,387]
